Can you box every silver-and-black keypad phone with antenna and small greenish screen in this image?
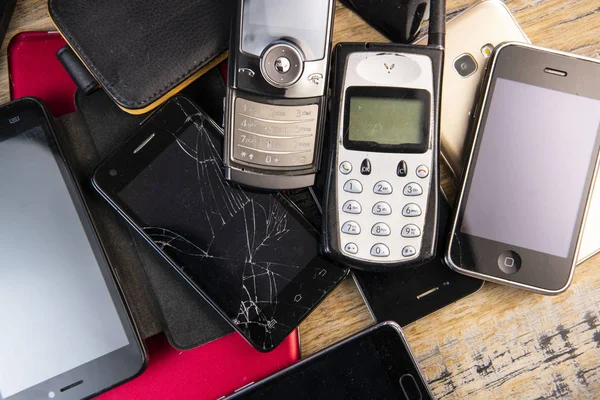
[323,1,446,270]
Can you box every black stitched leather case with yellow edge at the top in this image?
[48,0,234,114]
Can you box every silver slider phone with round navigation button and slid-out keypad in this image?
[224,0,335,190]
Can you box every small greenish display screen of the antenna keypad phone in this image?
[348,96,426,145]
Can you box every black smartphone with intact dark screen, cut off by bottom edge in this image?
[227,322,433,400]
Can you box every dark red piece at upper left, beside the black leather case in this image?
[8,32,77,117]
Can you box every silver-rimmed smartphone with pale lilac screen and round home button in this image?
[446,43,600,295]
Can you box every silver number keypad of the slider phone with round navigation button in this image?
[231,97,319,167]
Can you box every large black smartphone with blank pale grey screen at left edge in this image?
[0,98,146,400]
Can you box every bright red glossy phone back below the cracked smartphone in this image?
[97,330,300,400]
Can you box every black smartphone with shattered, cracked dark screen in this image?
[94,97,347,351]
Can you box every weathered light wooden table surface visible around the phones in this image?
[0,0,600,399]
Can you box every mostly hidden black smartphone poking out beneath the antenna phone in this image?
[354,189,483,326]
